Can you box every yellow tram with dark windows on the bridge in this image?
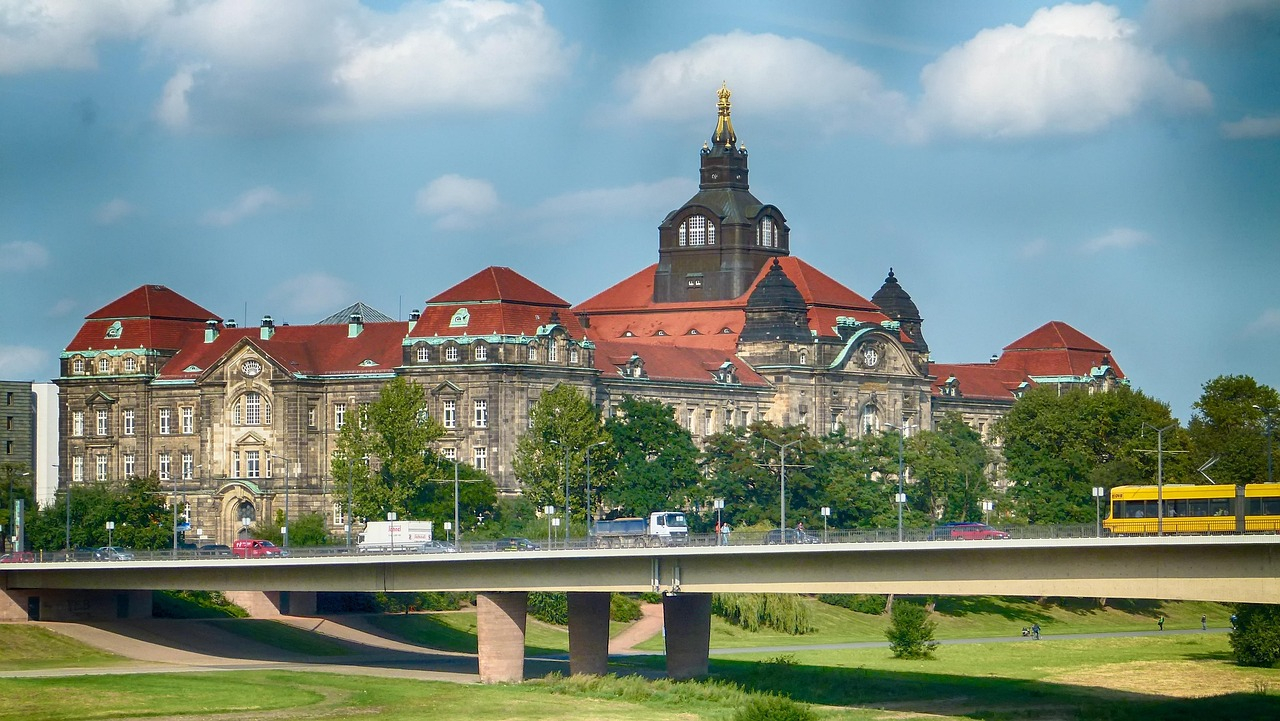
[1102,483,1280,535]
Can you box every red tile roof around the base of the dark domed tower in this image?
[573,256,908,350]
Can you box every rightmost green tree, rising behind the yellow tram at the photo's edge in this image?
[1187,375,1280,485]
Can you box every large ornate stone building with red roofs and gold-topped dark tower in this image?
[58,88,1124,542]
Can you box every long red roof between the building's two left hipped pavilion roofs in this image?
[160,321,408,379]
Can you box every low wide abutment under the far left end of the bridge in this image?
[0,589,151,621]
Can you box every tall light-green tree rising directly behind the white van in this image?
[333,377,444,519]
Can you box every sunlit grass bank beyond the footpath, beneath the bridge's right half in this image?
[636,595,1231,652]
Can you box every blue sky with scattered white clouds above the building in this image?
[0,0,1280,421]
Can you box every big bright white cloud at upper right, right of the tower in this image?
[918,3,1212,138]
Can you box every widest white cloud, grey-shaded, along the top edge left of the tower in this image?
[141,0,575,128]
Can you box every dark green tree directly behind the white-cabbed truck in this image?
[593,396,701,516]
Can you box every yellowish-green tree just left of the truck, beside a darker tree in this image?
[513,384,608,517]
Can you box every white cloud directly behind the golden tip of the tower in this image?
[617,32,908,131]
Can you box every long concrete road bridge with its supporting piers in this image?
[0,535,1280,681]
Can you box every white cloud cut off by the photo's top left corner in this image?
[0,0,173,74]
